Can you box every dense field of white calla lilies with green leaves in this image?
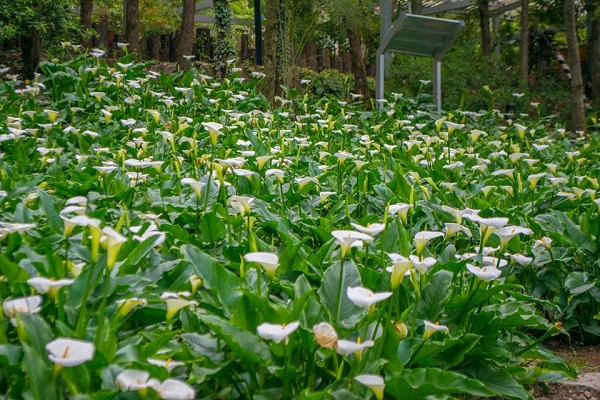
[0,51,600,400]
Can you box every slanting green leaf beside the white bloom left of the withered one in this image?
[198,315,271,364]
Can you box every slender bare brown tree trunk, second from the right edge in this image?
[564,0,585,132]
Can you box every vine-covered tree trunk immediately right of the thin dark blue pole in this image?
[263,0,281,102]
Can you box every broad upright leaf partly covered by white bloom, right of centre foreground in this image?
[318,260,365,328]
